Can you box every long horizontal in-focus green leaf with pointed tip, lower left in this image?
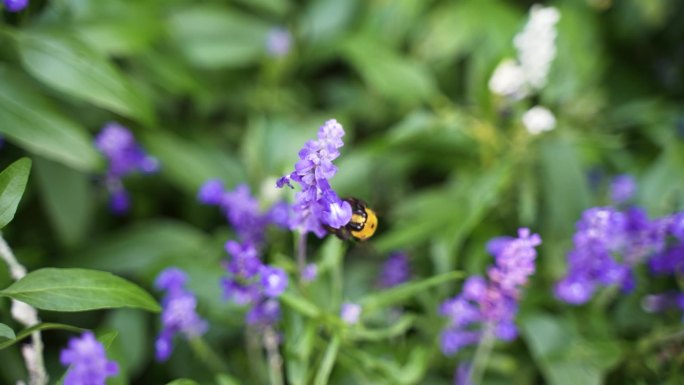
[0,268,160,312]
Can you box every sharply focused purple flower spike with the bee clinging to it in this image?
[276,119,351,238]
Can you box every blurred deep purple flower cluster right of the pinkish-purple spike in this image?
[555,207,665,305]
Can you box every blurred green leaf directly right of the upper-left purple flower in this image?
[141,132,245,195]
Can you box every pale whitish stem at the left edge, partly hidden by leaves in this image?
[0,235,48,385]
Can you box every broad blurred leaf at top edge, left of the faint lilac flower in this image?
[168,5,271,69]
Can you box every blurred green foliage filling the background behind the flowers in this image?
[0,0,684,385]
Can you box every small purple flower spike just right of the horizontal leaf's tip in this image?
[155,267,208,361]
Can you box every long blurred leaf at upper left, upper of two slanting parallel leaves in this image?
[17,31,155,126]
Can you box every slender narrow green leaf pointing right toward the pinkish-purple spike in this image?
[359,271,465,311]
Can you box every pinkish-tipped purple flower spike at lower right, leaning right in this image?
[439,228,541,355]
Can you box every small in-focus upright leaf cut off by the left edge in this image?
[0,158,31,229]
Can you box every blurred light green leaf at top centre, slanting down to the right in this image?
[343,34,437,104]
